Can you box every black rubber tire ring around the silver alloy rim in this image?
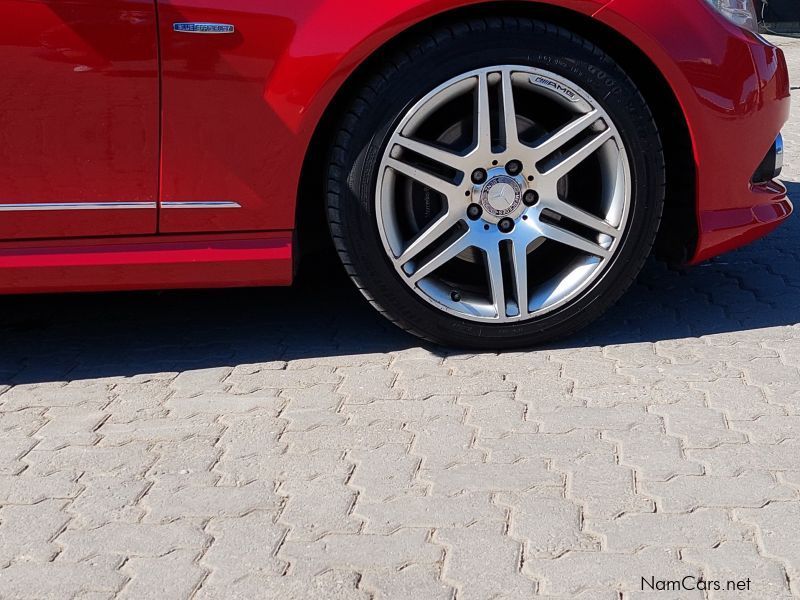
[326,17,665,350]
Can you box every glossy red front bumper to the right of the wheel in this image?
[595,0,792,263]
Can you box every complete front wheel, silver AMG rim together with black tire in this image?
[328,18,664,349]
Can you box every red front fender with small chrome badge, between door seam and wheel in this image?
[158,0,609,233]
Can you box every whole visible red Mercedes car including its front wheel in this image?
[0,0,792,349]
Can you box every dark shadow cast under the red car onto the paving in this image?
[0,183,800,384]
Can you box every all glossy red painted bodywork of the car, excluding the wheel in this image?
[0,0,791,292]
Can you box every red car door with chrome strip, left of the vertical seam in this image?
[0,0,159,240]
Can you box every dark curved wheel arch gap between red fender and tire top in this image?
[296,1,698,263]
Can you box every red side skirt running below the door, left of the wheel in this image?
[0,231,294,294]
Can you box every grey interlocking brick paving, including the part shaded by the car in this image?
[0,40,800,600]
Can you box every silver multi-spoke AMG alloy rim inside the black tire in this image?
[376,65,631,323]
